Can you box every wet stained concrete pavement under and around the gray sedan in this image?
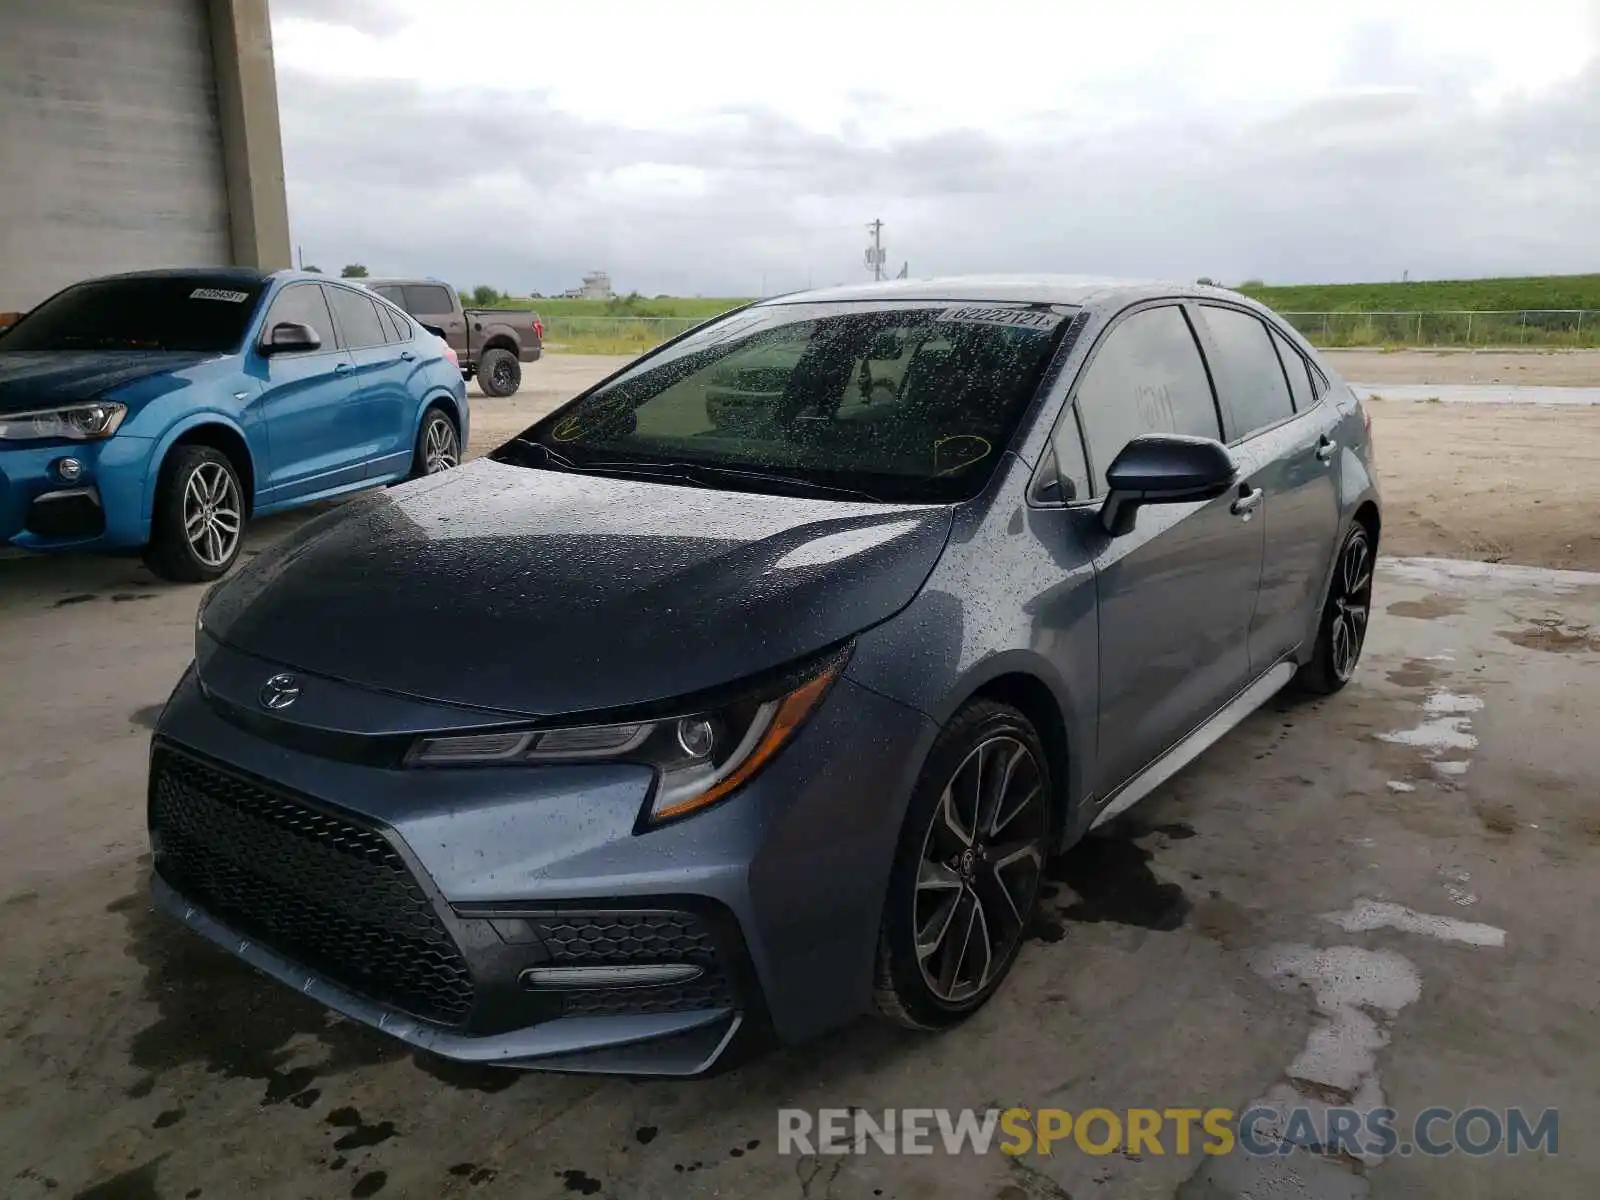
[0,556,1600,1200]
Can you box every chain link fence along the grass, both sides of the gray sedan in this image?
[544,309,1600,354]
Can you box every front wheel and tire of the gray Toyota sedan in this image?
[874,701,1054,1029]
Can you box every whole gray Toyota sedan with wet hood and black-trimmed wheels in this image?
[149,278,1379,1074]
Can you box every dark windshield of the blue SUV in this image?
[0,275,266,354]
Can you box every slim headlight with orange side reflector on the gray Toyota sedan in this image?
[406,654,845,824]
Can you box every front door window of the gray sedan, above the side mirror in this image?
[1062,304,1222,493]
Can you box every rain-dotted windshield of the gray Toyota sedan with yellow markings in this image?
[494,301,1074,502]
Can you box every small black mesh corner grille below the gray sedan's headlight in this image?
[533,912,736,1016]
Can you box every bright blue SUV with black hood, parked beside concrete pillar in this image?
[0,269,467,582]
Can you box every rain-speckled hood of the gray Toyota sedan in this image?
[202,459,950,715]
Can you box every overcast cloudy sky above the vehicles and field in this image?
[272,0,1600,296]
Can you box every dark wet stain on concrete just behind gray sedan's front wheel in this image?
[1045,821,1194,933]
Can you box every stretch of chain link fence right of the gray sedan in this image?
[1278,309,1600,347]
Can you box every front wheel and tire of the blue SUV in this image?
[144,445,246,584]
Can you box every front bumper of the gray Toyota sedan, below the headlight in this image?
[152,651,933,1075]
